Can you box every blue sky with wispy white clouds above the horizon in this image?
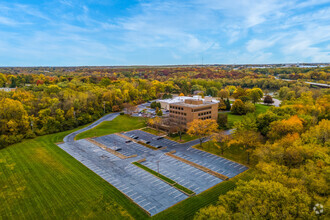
[0,0,330,66]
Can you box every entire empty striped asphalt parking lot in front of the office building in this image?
[58,130,248,216]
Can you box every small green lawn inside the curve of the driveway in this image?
[76,115,145,140]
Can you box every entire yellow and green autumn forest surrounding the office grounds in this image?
[0,67,330,219]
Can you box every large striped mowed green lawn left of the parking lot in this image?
[0,128,147,219]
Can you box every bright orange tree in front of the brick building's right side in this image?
[187,119,218,146]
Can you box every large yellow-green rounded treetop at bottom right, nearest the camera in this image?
[195,180,316,219]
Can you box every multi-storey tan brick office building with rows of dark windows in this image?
[169,99,218,128]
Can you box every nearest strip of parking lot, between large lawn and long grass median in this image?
[59,140,188,215]
